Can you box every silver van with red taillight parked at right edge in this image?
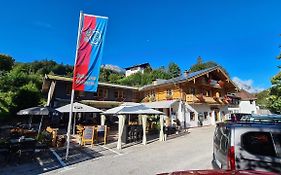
[212,116,281,173]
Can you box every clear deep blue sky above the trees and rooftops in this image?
[0,0,281,92]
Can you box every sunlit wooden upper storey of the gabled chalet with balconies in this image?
[141,68,236,105]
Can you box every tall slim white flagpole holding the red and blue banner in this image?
[65,11,83,160]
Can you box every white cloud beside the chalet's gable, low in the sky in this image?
[232,77,264,93]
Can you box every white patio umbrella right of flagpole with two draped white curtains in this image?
[103,103,163,149]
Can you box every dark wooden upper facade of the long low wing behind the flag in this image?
[42,75,140,108]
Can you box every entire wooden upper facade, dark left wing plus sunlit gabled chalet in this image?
[42,67,236,107]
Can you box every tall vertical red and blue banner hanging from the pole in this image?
[72,14,108,92]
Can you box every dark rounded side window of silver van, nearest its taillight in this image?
[241,132,277,157]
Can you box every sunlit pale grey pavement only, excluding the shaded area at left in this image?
[45,127,214,175]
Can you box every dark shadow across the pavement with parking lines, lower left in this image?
[0,144,115,175]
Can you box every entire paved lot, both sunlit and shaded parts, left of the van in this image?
[0,126,214,175]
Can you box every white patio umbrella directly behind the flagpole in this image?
[56,102,102,134]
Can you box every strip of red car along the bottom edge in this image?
[158,170,277,175]
